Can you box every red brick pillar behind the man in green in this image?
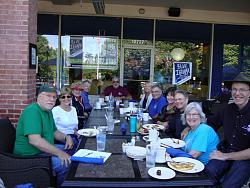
[0,0,37,124]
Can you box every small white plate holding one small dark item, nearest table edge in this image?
[148,167,176,180]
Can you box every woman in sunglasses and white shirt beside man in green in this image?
[52,88,78,152]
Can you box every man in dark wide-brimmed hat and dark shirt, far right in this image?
[206,73,250,188]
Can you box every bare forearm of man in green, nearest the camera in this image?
[28,134,71,166]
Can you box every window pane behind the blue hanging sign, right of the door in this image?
[154,41,209,100]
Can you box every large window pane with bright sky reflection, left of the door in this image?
[61,36,119,94]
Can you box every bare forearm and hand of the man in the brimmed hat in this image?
[210,148,250,161]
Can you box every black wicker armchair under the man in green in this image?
[0,119,56,187]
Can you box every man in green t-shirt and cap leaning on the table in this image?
[14,85,73,186]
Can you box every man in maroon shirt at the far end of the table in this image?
[102,77,132,99]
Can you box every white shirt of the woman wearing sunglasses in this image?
[52,106,78,134]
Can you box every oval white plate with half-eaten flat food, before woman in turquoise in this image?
[167,157,205,173]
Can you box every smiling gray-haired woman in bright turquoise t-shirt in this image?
[181,102,219,164]
